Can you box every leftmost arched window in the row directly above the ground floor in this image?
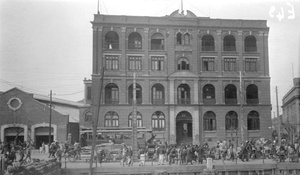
[105,83,119,104]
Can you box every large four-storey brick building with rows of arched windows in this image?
[81,11,272,144]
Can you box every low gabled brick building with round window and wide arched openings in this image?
[0,88,87,149]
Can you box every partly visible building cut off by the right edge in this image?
[282,78,300,140]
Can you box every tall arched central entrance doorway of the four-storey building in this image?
[176,111,193,144]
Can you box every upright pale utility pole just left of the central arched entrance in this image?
[132,72,138,161]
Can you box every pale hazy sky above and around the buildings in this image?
[0,0,300,115]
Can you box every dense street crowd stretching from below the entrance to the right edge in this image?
[116,138,300,166]
